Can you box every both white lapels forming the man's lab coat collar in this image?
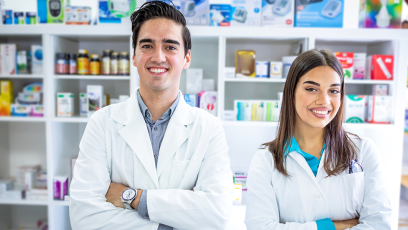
[111,89,196,188]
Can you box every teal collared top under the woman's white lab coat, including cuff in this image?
[283,137,336,230]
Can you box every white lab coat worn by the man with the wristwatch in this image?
[69,90,233,230]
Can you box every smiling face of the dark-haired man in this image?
[132,18,191,91]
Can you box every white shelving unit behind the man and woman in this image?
[0,25,408,230]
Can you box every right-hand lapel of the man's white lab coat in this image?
[157,97,195,177]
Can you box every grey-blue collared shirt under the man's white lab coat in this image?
[137,90,180,230]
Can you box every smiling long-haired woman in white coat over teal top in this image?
[245,50,392,230]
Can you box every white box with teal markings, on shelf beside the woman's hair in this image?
[344,95,367,123]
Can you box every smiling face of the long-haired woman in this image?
[294,66,341,128]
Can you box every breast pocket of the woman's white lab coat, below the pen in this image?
[343,172,364,215]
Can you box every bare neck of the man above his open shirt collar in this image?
[139,86,178,121]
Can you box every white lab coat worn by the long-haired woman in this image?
[245,138,392,230]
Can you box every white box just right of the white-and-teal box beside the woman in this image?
[367,96,392,124]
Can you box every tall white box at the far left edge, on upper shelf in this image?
[0,44,16,75]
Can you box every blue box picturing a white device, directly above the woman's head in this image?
[295,0,344,28]
